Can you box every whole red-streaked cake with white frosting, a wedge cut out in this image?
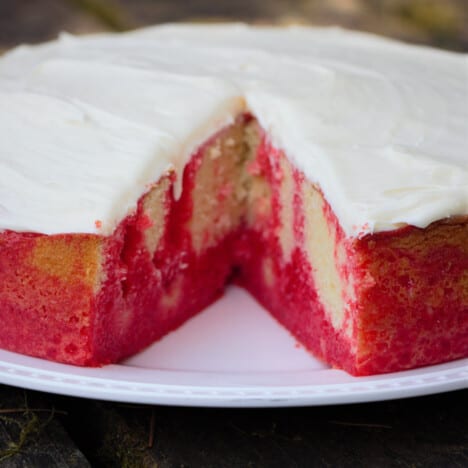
[0,24,468,375]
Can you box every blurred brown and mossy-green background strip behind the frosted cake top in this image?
[0,0,468,51]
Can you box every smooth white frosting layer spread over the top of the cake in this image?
[0,25,468,236]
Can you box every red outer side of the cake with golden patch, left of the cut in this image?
[0,232,103,364]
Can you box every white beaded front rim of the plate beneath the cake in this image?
[0,350,468,408]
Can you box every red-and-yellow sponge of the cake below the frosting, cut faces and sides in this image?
[0,115,468,375]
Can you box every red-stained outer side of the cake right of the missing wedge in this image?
[355,219,468,374]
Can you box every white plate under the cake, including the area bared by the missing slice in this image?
[0,287,468,407]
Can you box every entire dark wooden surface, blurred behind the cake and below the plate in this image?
[0,0,468,468]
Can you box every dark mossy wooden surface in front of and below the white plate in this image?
[0,386,468,468]
